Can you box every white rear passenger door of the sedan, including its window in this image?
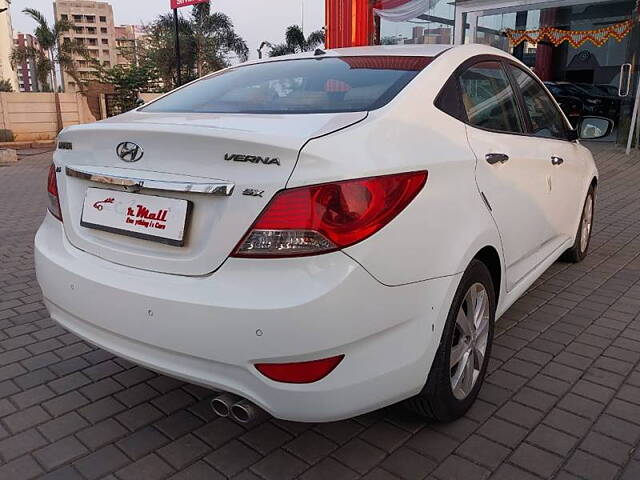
[458,59,554,290]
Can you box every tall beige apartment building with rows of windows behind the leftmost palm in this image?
[53,0,118,92]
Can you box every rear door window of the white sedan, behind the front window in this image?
[458,61,522,133]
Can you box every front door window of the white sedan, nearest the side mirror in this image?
[509,65,567,139]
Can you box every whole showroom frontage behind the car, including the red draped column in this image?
[326,0,640,144]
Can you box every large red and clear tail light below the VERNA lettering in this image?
[232,171,427,258]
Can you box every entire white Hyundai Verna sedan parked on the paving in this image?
[35,45,611,421]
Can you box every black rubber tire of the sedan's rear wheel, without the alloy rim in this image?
[405,260,496,422]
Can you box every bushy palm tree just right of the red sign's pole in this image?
[191,3,249,77]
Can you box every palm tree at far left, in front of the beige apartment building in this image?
[11,8,88,90]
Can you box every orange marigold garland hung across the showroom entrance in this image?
[506,20,633,48]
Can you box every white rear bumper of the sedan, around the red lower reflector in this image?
[35,214,460,421]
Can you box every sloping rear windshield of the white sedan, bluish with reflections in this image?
[141,56,433,114]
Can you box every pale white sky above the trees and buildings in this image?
[11,0,324,58]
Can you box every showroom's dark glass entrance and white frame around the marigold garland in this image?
[463,0,640,145]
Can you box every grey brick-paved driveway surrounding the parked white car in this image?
[0,147,640,480]
